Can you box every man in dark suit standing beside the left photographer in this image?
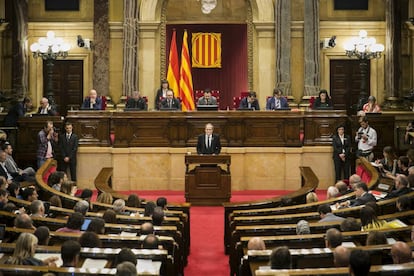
[59,122,78,181]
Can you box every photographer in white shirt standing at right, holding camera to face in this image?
[355,117,377,162]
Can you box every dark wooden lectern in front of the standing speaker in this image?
[185,154,231,205]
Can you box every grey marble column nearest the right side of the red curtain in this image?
[275,0,292,95]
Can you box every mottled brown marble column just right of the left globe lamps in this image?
[91,0,109,95]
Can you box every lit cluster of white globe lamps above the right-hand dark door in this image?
[344,30,384,59]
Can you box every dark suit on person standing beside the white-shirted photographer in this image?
[332,134,351,181]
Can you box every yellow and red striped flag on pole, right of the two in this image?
[180,30,195,111]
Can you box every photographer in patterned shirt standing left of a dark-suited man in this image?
[37,121,58,168]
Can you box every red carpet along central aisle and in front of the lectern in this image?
[87,190,326,276]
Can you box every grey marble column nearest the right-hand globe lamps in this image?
[303,0,320,96]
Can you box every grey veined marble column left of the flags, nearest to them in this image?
[122,0,139,96]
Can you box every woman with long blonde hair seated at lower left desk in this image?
[6,233,58,267]
